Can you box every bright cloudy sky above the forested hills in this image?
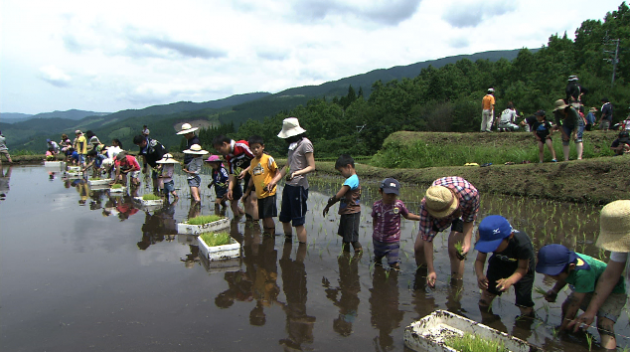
[0,0,621,114]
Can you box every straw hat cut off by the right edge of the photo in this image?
[595,200,630,253]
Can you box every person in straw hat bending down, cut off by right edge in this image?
[568,200,630,349]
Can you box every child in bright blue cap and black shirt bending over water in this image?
[475,215,536,317]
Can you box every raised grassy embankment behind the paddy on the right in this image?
[317,132,630,204]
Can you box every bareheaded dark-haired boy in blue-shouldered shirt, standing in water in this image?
[324,154,363,253]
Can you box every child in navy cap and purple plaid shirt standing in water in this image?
[372,178,420,270]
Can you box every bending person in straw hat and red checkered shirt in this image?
[414,176,479,287]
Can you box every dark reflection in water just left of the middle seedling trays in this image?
[134,199,178,250]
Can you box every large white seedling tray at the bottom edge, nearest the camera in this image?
[404,310,542,352]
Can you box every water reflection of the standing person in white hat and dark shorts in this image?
[279,243,316,350]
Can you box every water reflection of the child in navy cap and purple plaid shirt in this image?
[370,266,404,351]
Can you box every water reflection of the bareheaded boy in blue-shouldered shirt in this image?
[323,251,363,336]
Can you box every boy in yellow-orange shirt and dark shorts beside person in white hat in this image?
[245,136,278,235]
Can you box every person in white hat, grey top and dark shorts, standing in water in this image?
[267,117,315,243]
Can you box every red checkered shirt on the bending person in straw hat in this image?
[418,176,479,242]
